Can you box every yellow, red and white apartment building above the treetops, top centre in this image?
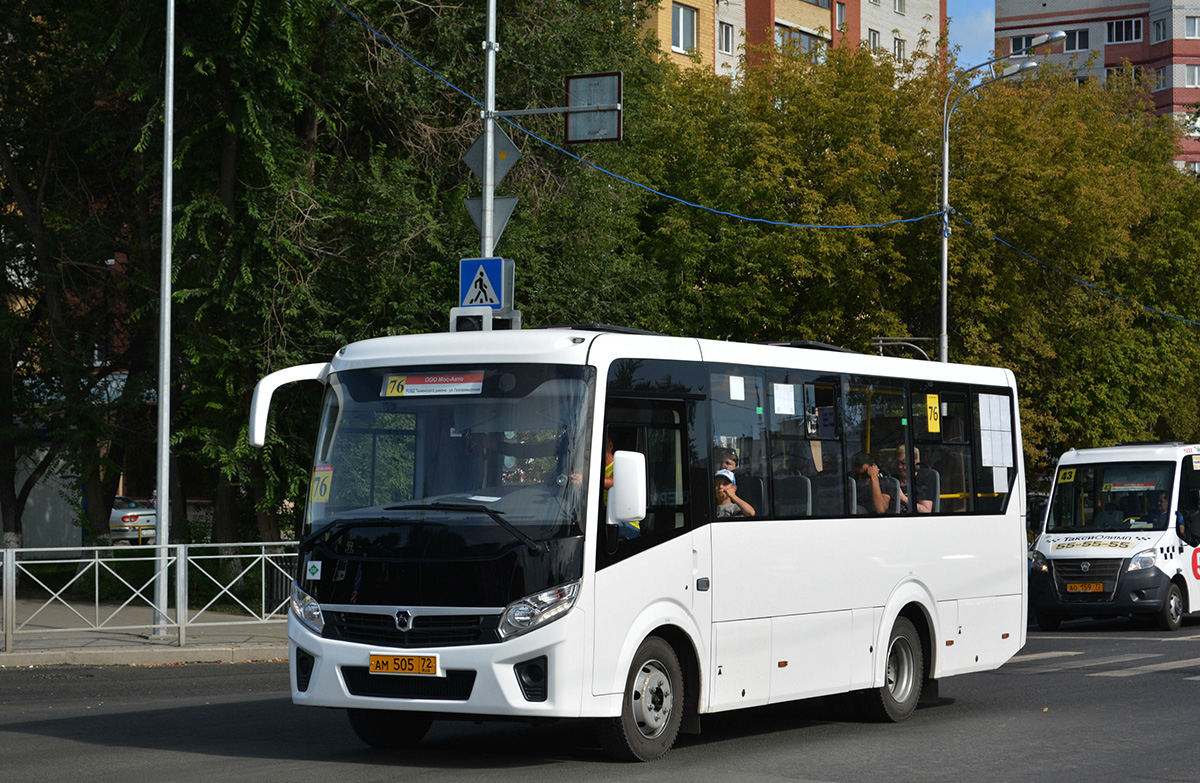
[649,0,946,78]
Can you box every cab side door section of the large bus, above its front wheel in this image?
[593,363,712,694]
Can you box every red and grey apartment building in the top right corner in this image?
[996,0,1200,169]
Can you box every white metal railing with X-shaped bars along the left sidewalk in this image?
[0,542,296,652]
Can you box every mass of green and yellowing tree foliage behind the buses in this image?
[7,0,1200,540]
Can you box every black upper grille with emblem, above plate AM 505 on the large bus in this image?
[324,611,500,647]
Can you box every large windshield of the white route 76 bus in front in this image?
[306,364,594,557]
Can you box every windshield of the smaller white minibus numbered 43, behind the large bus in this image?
[1046,462,1175,533]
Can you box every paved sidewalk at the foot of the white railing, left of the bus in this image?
[0,599,288,668]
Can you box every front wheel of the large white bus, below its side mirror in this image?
[596,636,685,761]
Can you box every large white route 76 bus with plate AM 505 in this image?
[250,327,1027,760]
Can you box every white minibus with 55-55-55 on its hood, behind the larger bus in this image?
[1030,441,1200,630]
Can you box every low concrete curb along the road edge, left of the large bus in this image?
[0,644,288,669]
